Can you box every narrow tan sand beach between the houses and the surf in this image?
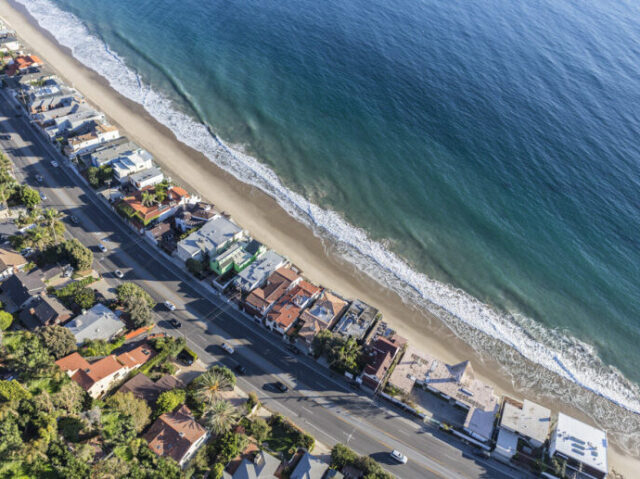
[0,3,640,477]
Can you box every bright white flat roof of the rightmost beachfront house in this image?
[551,413,608,473]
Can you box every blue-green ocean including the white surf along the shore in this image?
[16,0,640,454]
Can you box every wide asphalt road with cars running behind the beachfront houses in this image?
[0,87,522,479]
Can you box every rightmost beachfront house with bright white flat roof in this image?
[549,413,608,479]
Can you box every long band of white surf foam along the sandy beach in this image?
[17,0,640,422]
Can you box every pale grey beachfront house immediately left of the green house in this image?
[175,215,245,261]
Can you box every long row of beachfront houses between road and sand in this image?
[0,29,607,479]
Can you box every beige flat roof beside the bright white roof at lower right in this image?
[500,398,551,443]
